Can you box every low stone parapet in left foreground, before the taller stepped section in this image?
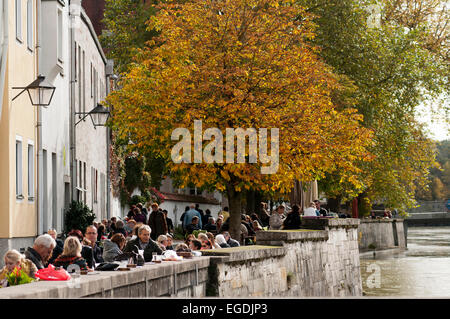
[0,257,209,299]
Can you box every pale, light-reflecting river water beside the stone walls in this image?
[360,227,450,297]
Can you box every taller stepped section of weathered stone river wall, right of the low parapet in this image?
[206,219,362,297]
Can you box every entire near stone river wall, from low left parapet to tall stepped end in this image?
[0,218,362,298]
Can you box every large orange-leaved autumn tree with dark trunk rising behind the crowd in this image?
[108,0,370,238]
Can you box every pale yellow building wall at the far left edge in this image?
[0,0,37,238]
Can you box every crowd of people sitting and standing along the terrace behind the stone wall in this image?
[0,201,348,286]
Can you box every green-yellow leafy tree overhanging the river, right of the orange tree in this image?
[300,0,448,215]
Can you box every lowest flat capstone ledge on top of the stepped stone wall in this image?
[202,245,286,263]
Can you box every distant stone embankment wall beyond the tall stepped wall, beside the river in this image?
[358,219,407,251]
